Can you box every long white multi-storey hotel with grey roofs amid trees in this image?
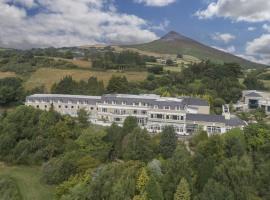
[25,94,246,136]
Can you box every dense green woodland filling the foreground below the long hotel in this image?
[0,106,270,200]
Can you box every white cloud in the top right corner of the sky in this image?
[195,0,270,22]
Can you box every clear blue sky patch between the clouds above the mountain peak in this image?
[117,0,266,57]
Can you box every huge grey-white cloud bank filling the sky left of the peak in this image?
[0,0,157,48]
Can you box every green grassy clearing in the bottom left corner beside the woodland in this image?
[0,163,54,200]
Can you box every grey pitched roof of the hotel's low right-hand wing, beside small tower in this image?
[186,113,225,124]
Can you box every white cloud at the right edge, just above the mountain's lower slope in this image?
[246,34,270,64]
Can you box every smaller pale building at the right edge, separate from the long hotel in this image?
[234,90,270,115]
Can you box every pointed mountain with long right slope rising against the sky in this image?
[125,31,266,68]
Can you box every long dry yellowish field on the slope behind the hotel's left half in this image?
[24,68,147,92]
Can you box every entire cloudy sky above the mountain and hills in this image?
[0,0,270,64]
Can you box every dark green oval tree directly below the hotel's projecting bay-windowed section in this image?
[159,126,177,158]
